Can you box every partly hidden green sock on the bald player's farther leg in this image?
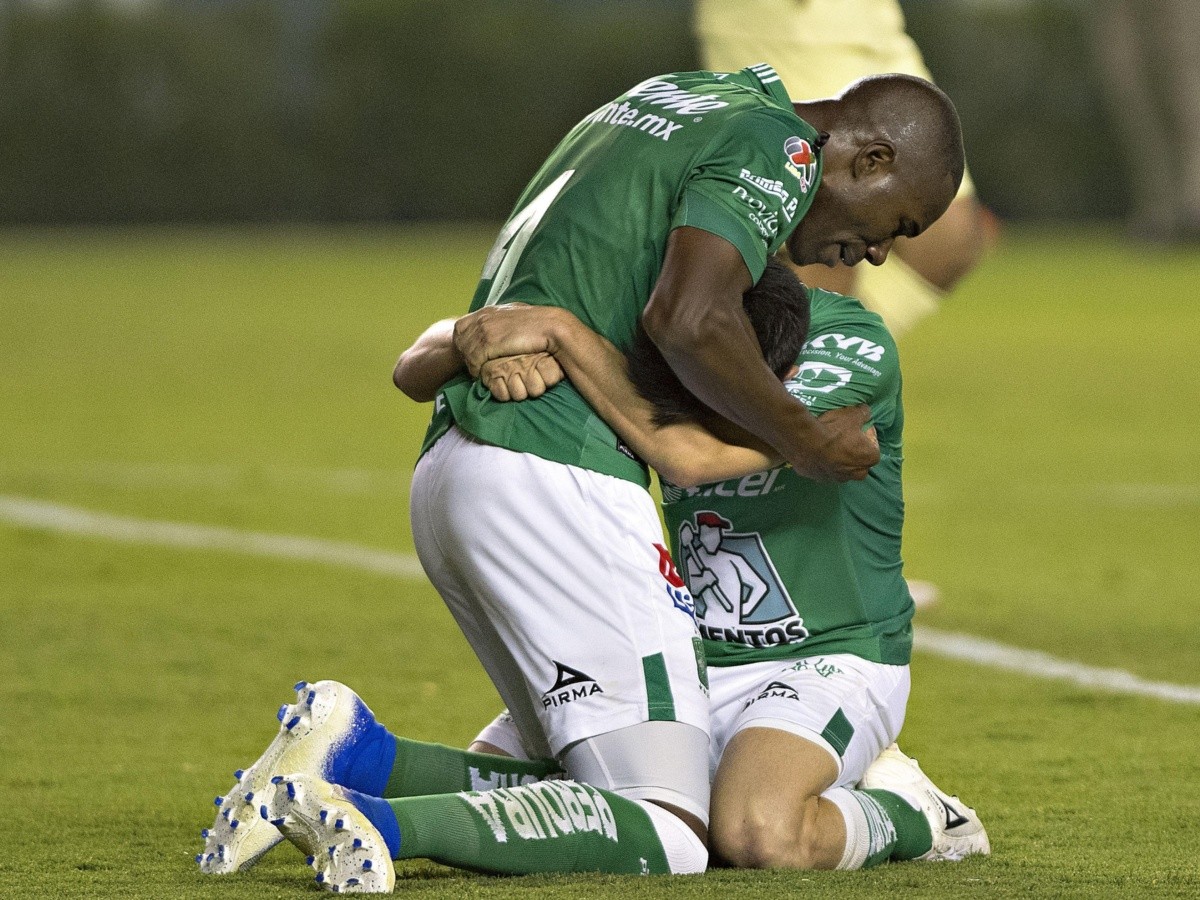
[383,738,560,798]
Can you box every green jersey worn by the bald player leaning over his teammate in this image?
[422,65,821,486]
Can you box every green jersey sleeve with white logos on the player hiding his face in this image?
[787,313,900,427]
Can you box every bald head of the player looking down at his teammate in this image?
[788,74,965,271]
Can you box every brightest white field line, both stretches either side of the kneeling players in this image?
[0,496,1200,704]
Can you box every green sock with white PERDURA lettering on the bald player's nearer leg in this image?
[388,781,671,875]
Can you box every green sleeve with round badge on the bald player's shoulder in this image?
[671,109,820,281]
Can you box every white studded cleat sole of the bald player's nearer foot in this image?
[263,775,396,894]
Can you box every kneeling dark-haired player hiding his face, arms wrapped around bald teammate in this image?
[427,271,990,869]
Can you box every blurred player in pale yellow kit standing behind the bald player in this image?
[695,0,996,337]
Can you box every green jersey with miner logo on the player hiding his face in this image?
[662,290,913,666]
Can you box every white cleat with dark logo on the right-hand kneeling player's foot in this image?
[858,744,991,860]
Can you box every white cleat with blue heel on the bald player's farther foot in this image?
[197,682,395,875]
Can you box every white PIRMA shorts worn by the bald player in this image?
[412,428,709,756]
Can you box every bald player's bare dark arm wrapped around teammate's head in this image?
[642,227,880,481]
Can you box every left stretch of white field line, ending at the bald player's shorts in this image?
[0,496,425,578]
